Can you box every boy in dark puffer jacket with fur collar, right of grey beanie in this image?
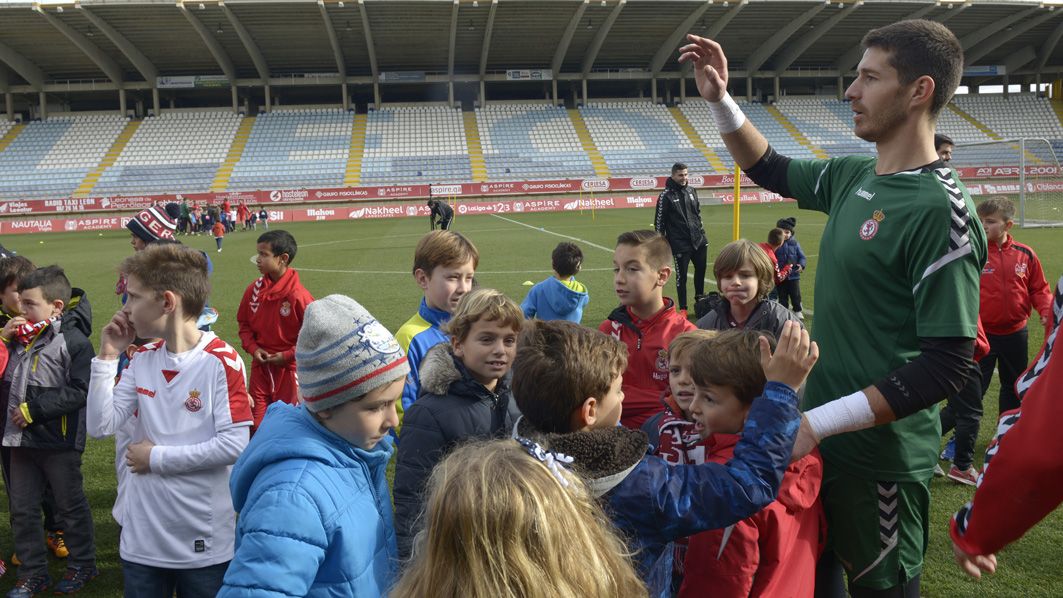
[394,289,524,560]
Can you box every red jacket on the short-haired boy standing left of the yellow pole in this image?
[598,297,697,430]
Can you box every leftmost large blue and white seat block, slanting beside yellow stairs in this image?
[0,114,128,199]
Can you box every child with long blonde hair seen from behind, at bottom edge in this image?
[390,439,646,598]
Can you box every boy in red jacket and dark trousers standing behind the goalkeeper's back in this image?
[977,197,1052,413]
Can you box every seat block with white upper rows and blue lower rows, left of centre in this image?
[359,105,472,185]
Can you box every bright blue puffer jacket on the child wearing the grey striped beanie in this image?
[218,403,398,598]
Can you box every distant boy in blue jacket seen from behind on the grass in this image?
[521,242,590,324]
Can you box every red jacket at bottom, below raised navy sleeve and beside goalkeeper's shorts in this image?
[679,434,827,598]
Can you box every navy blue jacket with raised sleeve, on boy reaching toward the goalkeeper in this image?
[517,382,800,598]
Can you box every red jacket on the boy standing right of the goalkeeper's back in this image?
[980,235,1052,336]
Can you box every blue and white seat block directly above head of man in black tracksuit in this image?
[579,101,712,176]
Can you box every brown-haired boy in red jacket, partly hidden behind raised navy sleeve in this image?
[679,329,826,598]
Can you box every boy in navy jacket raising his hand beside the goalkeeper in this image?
[512,322,819,598]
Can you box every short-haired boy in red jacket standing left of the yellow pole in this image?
[598,230,697,430]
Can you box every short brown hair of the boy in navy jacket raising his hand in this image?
[510,320,627,433]
